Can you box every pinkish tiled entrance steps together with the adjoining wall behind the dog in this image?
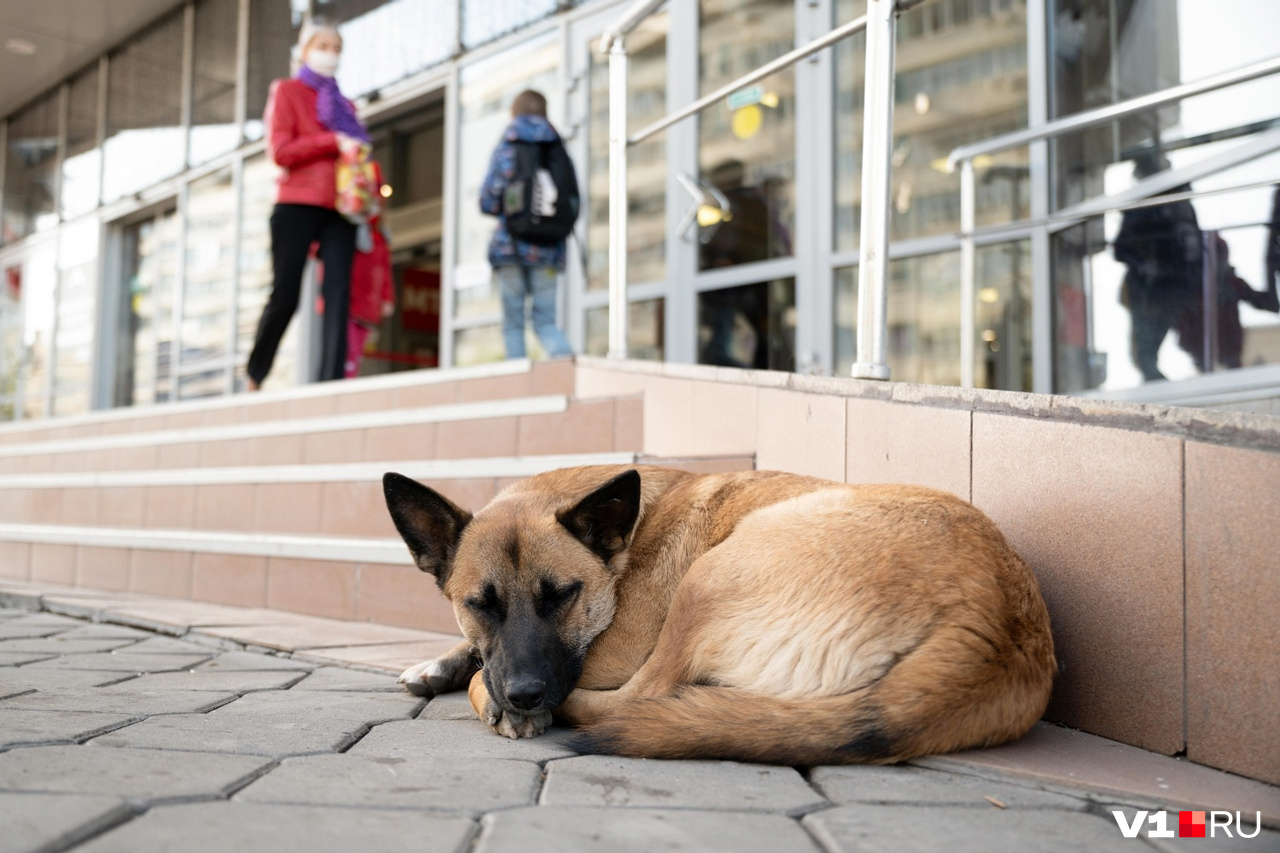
[0,357,1280,784]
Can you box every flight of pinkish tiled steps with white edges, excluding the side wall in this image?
[0,361,751,633]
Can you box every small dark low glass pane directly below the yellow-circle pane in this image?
[698,278,796,370]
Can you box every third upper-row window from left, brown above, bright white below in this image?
[102,13,187,201]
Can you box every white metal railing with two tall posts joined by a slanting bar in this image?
[600,0,924,379]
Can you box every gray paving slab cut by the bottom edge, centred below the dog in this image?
[475,806,818,853]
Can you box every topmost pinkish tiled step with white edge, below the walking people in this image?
[0,360,573,447]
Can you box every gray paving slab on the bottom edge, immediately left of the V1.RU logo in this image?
[803,806,1140,853]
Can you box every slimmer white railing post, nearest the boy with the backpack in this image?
[608,36,627,359]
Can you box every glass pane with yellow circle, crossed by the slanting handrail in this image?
[696,0,795,269]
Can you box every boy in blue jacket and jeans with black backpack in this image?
[480,90,579,359]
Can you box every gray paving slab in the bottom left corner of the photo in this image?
[0,792,133,853]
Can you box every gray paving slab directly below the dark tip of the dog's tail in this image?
[540,756,829,816]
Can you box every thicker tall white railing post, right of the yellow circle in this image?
[852,0,897,379]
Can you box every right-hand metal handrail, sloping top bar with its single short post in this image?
[947,50,1280,388]
